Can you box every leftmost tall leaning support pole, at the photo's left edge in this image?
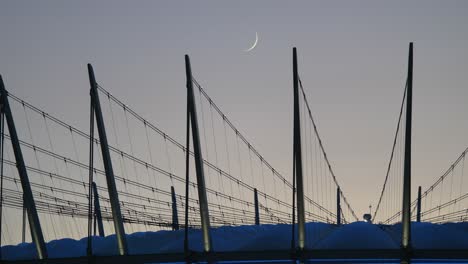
[0,76,47,259]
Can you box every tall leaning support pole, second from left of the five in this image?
[88,64,128,255]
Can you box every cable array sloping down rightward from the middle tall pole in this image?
[193,78,344,226]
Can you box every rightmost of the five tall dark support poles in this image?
[401,42,413,261]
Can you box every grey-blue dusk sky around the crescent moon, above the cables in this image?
[0,0,468,221]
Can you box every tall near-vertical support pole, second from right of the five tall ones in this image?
[293,48,306,251]
